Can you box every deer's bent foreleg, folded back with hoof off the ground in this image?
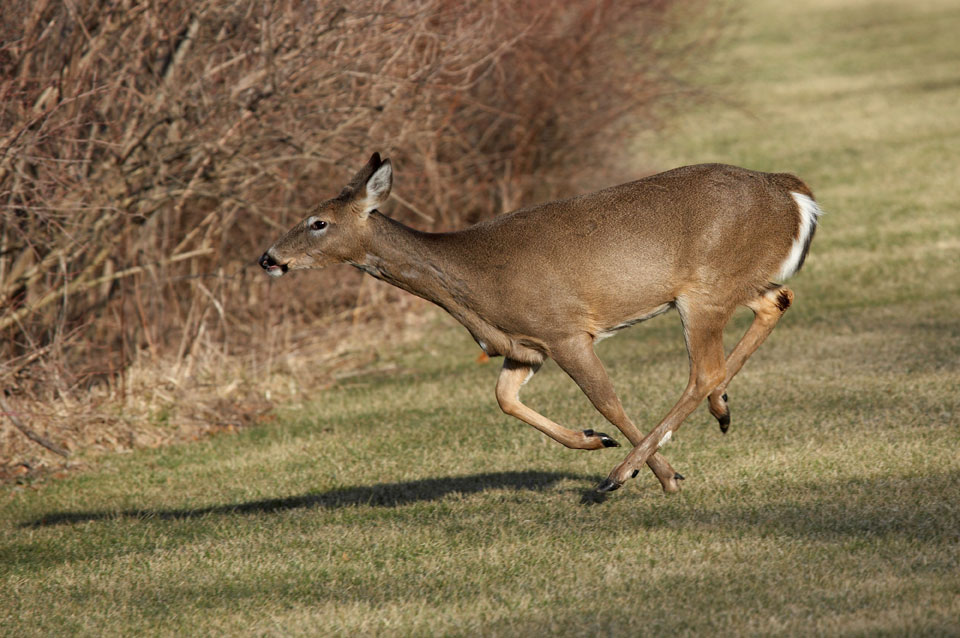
[497,358,620,450]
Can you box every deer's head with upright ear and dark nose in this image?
[258,153,393,277]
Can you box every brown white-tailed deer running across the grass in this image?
[258,153,822,494]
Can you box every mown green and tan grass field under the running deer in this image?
[0,0,960,636]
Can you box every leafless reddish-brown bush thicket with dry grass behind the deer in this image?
[0,0,713,470]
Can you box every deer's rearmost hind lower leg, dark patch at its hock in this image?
[709,286,793,434]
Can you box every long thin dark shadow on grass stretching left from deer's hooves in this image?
[21,471,589,527]
